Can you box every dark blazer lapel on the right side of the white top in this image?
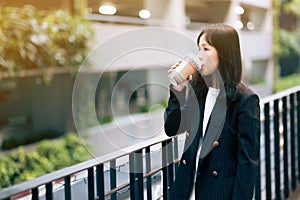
[200,92,226,158]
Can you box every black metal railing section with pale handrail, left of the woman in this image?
[0,133,183,200]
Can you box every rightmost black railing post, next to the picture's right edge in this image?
[290,94,297,190]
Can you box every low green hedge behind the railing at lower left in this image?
[0,133,90,189]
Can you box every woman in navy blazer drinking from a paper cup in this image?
[164,24,260,200]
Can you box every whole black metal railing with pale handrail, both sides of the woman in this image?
[0,86,300,200]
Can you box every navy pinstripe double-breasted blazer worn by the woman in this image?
[164,83,260,200]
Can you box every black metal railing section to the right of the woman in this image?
[255,86,300,200]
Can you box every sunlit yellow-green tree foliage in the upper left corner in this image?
[0,5,93,73]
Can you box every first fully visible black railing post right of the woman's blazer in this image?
[264,103,272,200]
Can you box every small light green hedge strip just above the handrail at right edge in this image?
[274,73,300,93]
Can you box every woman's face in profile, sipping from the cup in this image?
[198,34,219,77]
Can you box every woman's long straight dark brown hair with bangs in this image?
[191,24,242,97]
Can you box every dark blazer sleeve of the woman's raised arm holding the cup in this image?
[164,85,186,136]
